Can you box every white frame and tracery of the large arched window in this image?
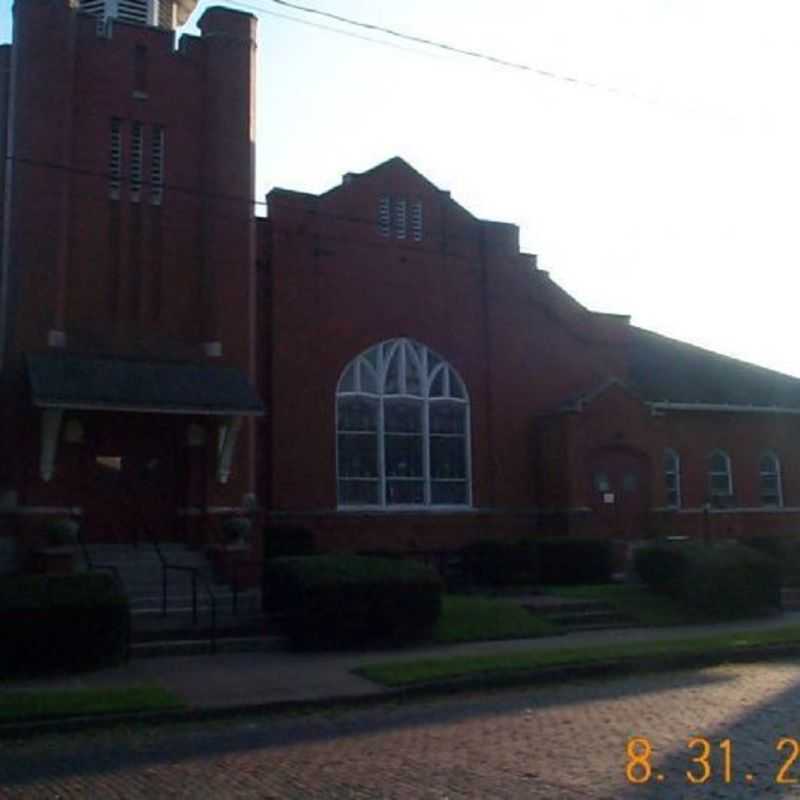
[334,338,472,512]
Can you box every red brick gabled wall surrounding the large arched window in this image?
[268,160,636,546]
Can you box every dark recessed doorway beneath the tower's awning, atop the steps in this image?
[84,412,180,544]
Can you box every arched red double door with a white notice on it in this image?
[588,447,650,541]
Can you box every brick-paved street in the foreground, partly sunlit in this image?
[0,662,800,800]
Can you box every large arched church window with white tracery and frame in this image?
[336,339,471,507]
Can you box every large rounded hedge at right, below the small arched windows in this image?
[635,543,781,619]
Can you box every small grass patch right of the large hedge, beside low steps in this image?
[433,594,558,644]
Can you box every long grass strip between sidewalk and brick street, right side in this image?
[356,625,800,687]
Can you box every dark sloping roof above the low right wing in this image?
[629,326,800,409]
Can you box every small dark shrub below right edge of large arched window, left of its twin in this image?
[461,539,539,587]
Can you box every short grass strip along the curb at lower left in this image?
[0,686,185,722]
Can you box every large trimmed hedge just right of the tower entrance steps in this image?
[264,555,442,648]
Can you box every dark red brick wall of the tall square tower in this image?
[0,0,257,536]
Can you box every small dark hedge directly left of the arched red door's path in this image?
[535,536,614,585]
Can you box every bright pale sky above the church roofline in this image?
[0,0,800,375]
